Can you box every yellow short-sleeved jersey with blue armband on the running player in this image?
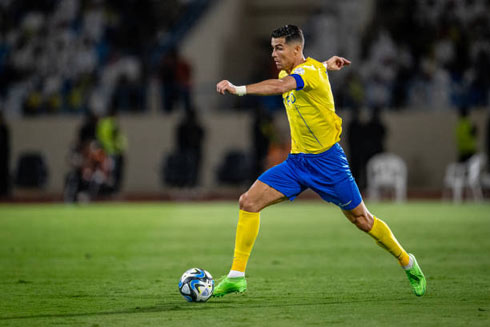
[279,57,342,153]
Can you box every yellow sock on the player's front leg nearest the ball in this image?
[231,210,260,272]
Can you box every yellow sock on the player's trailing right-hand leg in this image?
[368,216,410,266]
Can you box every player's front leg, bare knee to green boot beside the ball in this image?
[213,180,286,297]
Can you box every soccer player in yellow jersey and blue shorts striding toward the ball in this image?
[213,25,426,297]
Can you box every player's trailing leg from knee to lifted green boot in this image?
[342,202,427,296]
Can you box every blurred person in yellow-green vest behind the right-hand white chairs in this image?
[455,107,477,162]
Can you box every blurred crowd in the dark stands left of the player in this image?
[0,0,192,116]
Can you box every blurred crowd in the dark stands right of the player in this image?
[336,0,490,110]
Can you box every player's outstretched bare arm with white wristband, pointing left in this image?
[216,75,297,95]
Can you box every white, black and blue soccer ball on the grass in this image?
[179,268,214,302]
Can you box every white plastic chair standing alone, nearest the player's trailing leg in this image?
[367,153,407,202]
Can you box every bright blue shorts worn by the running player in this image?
[258,143,362,210]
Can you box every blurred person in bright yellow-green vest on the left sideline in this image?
[96,105,127,192]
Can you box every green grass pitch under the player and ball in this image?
[0,201,490,327]
